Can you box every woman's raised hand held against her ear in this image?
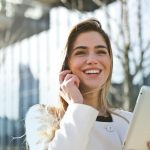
[59,70,83,104]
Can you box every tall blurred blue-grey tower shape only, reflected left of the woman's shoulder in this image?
[19,64,39,119]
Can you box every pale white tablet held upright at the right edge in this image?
[123,86,150,150]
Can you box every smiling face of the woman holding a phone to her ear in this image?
[68,31,111,92]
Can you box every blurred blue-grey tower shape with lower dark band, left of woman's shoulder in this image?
[0,64,39,150]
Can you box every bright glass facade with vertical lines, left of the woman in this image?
[0,8,93,150]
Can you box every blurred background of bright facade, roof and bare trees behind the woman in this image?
[0,0,150,150]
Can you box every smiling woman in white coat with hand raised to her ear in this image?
[26,19,150,150]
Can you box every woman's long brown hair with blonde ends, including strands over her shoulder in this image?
[46,18,113,140]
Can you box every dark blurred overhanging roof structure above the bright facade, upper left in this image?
[0,0,116,48]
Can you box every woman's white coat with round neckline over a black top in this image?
[26,104,132,150]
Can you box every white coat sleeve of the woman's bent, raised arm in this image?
[25,104,98,150]
